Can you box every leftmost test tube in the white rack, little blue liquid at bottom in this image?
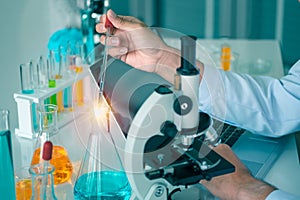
[20,62,34,94]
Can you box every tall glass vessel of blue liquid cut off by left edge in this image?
[0,109,15,199]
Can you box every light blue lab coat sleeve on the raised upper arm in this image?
[199,60,300,137]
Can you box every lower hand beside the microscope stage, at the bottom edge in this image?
[200,144,275,200]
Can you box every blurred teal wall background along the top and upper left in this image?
[0,0,300,130]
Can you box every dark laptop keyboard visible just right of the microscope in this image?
[213,119,246,147]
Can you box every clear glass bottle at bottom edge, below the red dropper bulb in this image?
[29,163,57,200]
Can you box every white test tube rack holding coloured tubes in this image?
[13,65,93,139]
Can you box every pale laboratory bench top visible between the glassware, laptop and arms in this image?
[12,38,300,199]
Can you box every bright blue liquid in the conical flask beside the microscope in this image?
[74,171,131,200]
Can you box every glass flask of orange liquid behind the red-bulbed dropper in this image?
[31,104,73,185]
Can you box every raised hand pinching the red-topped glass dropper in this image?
[96,10,180,81]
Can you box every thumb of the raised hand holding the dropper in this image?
[106,9,146,31]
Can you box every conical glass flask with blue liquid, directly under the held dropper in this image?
[74,122,131,200]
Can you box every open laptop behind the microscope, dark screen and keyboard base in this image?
[90,57,286,179]
